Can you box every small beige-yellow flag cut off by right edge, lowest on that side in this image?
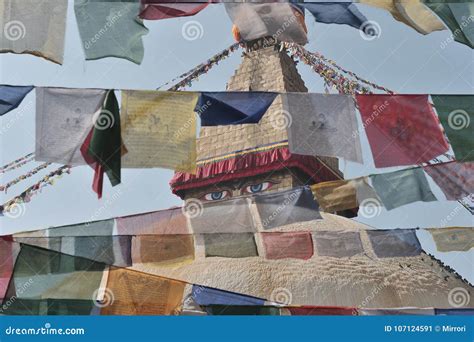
[428,227,474,252]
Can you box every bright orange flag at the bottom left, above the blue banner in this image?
[100,268,186,315]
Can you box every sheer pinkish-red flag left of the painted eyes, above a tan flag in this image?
[117,208,191,235]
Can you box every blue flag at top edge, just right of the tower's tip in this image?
[294,1,368,29]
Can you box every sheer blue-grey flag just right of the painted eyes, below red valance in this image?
[255,187,321,229]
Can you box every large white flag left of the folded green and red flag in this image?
[35,88,106,165]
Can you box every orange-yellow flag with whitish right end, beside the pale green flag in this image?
[311,177,381,213]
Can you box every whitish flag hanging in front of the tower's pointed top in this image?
[225,2,308,45]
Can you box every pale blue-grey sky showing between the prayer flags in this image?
[0,0,474,283]
